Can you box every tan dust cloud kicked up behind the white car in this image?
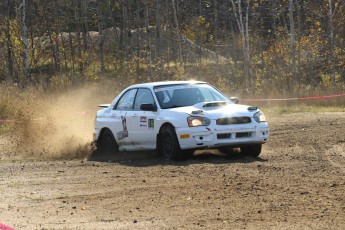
[0,84,118,160]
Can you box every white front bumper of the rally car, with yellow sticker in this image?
[176,122,269,149]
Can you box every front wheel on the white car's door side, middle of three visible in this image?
[160,126,183,160]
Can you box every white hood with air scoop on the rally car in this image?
[167,102,259,119]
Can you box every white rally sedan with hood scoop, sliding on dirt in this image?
[93,81,269,160]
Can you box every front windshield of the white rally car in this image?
[154,84,229,109]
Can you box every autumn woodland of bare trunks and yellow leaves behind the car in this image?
[0,0,345,93]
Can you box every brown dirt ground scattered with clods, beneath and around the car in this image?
[0,113,345,229]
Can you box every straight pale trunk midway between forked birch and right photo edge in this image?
[289,0,296,89]
